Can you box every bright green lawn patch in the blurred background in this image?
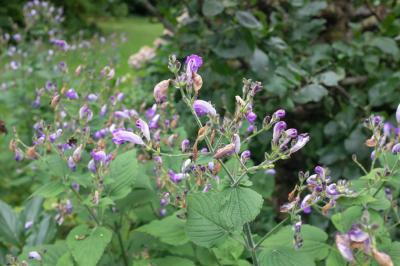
[97,17,163,73]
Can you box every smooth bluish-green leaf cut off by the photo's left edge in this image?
[0,200,19,245]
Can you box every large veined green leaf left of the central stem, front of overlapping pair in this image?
[186,193,229,247]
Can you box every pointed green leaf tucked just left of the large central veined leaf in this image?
[136,214,189,246]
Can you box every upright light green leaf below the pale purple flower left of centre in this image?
[108,150,140,200]
